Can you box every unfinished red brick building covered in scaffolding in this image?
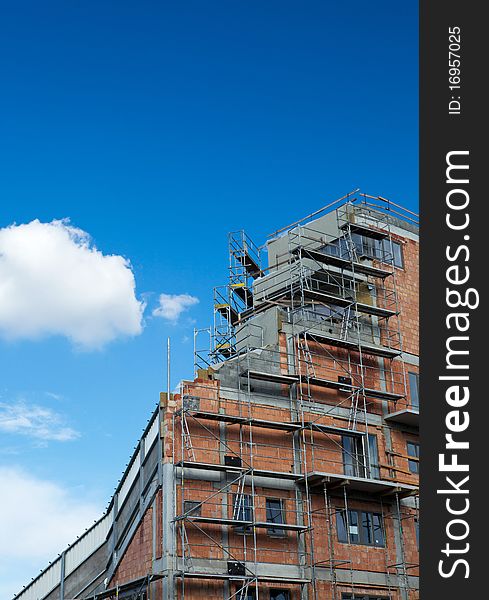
[16,190,419,600]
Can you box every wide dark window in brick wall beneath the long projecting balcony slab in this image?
[336,510,385,546]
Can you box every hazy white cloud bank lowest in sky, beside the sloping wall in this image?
[0,467,101,599]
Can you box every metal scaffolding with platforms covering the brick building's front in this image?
[183,194,417,600]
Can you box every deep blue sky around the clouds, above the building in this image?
[0,0,418,597]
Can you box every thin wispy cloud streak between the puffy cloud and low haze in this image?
[0,401,80,442]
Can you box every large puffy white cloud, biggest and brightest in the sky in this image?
[0,219,144,349]
